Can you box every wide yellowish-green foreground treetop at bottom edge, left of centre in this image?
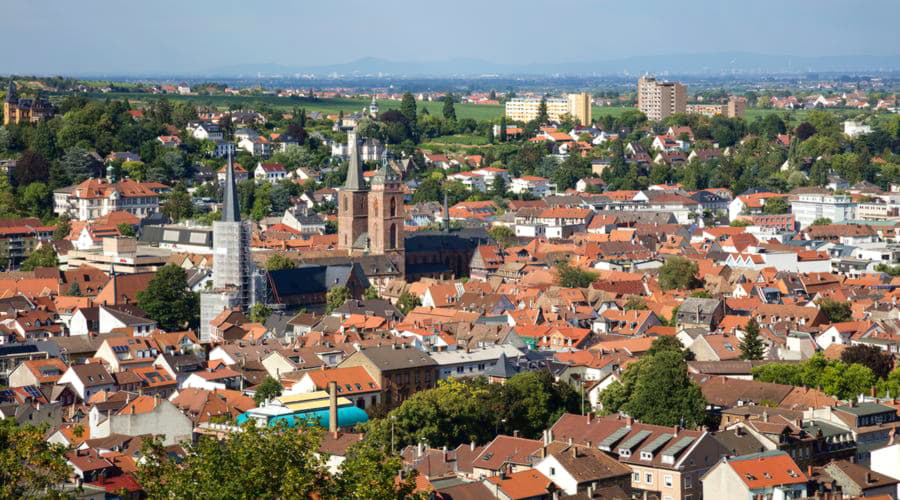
[137,425,326,500]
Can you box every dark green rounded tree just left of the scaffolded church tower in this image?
[137,264,200,331]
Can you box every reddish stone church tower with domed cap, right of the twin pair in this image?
[369,153,406,276]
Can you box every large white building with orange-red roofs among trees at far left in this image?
[53,179,159,220]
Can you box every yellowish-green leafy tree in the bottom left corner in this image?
[0,418,71,498]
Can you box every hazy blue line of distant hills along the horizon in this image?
[204,52,900,77]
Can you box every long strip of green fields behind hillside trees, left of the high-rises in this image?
[79,92,502,121]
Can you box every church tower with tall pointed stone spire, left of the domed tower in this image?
[338,128,368,252]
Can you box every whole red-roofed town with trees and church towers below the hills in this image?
[0,68,900,500]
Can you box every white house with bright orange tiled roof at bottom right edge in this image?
[702,451,808,500]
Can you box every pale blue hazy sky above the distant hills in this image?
[0,0,900,74]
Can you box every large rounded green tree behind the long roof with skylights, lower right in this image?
[600,349,706,427]
